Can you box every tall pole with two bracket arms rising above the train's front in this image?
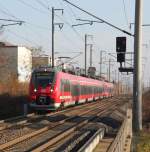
[52,7,63,68]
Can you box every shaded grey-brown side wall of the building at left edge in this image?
[0,46,18,83]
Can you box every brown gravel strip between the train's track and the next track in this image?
[0,100,112,144]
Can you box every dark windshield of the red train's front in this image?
[32,72,54,88]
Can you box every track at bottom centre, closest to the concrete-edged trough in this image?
[33,103,118,152]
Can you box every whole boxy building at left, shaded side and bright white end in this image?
[0,42,32,82]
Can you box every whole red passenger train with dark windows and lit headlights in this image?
[29,67,113,110]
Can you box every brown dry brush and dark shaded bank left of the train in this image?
[0,79,29,119]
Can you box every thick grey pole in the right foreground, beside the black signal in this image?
[133,0,142,133]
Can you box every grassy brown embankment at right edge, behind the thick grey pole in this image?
[137,91,150,152]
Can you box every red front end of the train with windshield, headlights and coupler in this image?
[29,68,57,110]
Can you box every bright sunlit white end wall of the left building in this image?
[17,46,32,82]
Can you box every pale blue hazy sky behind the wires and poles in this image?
[0,0,150,85]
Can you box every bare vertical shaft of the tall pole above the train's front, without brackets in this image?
[52,7,55,68]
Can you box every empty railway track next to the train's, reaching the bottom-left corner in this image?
[0,99,123,151]
